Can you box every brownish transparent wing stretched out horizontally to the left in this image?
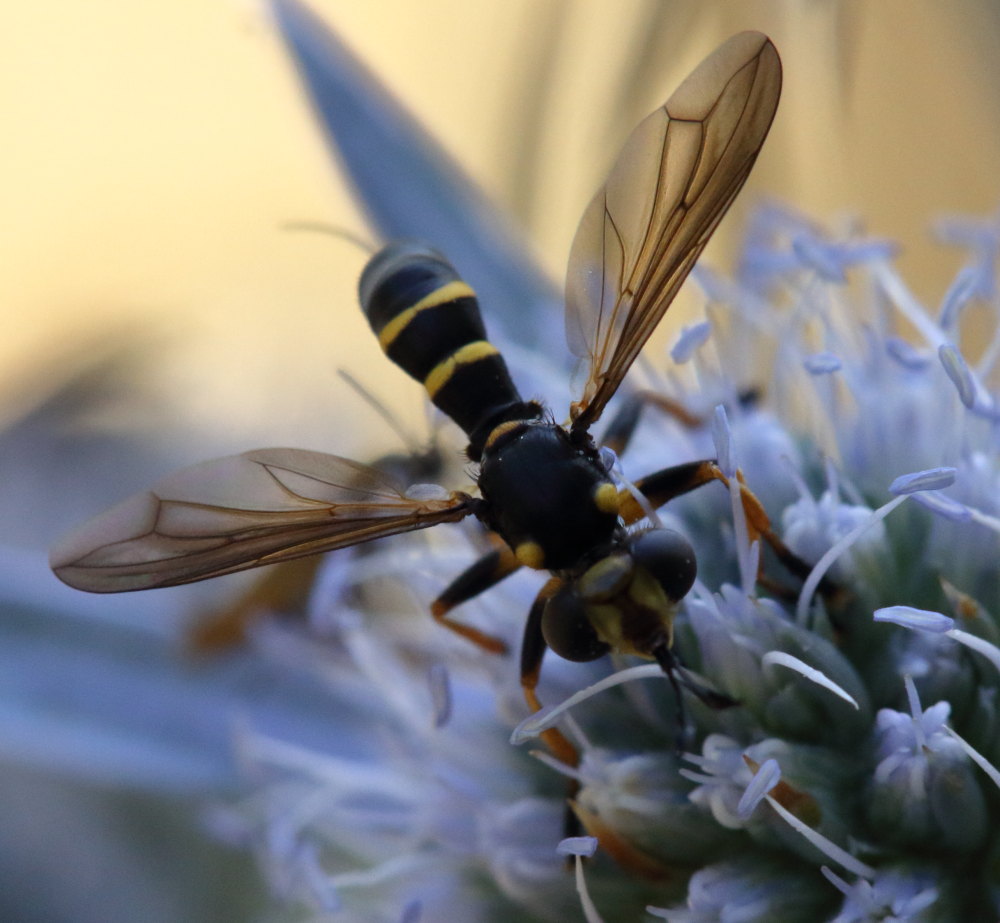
[50,449,475,593]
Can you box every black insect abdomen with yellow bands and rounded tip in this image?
[359,243,537,461]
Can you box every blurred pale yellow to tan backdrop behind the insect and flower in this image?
[0,0,1000,508]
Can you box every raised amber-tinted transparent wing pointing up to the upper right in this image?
[566,32,781,429]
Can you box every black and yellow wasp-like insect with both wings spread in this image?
[51,32,781,752]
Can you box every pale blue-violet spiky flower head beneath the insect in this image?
[217,4,1000,923]
